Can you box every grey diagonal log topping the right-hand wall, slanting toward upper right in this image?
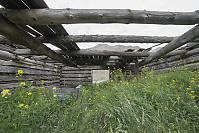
[139,25,199,66]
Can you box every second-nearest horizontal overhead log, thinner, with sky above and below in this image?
[0,35,199,44]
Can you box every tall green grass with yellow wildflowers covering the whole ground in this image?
[0,70,199,133]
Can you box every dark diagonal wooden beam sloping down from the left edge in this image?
[0,15,76,66]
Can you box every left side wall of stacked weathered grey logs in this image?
[0,44,60,89]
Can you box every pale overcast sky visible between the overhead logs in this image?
[45,0,199,49]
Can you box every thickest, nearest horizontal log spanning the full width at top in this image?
[1,9,199,25]
